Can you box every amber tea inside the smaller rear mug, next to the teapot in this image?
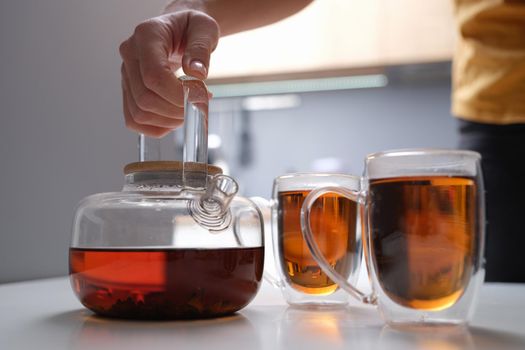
[278,191,357,295]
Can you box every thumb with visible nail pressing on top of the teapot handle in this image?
[182,12,219,79]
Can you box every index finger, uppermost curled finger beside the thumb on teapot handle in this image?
[133,22,184,107]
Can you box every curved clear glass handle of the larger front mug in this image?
[301,186,377,305]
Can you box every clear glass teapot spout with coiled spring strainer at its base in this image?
[190,174,239,231]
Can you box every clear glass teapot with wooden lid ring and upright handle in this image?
[69,77,264,319]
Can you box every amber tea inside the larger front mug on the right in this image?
[369,176,479,310]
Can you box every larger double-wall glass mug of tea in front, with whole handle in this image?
[301,149,485,325]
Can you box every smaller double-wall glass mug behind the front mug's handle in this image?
[259,173,362,307]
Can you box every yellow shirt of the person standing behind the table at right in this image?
[452,0,525,124]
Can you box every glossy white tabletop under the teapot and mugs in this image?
[0,278,525,350]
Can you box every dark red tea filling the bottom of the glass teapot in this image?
[69,247,264,319]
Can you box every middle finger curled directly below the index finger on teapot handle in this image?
[121,60,184,118]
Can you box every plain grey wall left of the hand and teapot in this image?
[0,0,165,282]
